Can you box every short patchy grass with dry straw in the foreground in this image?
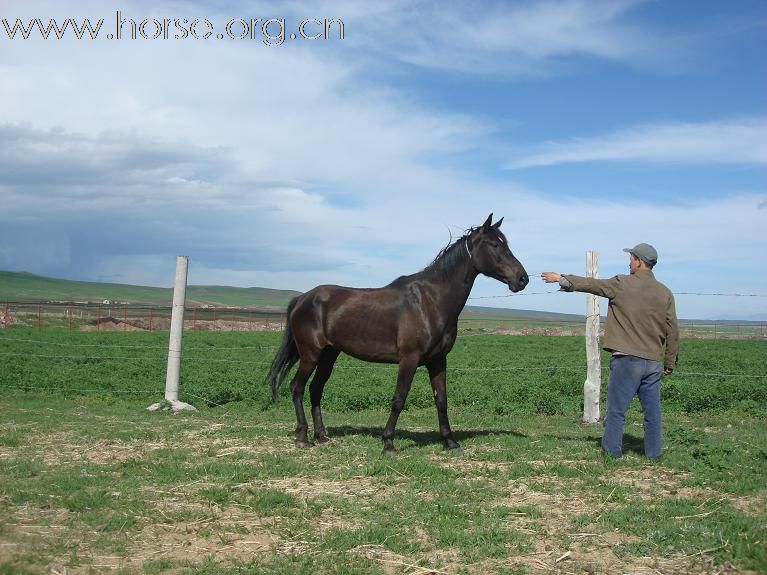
[0,394,767,574]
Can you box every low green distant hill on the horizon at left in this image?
[0,271,301,308]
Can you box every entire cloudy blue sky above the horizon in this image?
[0,0,767,320]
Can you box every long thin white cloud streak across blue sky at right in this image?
[509,117,767,169]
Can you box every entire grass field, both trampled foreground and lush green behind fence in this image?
[0,329,767,574]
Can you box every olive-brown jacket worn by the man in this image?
[562,270,679,369]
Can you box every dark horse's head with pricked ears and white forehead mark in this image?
[466,214,530,292]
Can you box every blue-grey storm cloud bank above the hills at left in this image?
[0,124,352,279]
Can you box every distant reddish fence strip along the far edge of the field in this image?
[0,300,767,339]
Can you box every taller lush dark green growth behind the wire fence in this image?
[0,328,767,417]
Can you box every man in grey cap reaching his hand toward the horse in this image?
[541,243,679,459]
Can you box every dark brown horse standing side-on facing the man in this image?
[267,214,528,452]
